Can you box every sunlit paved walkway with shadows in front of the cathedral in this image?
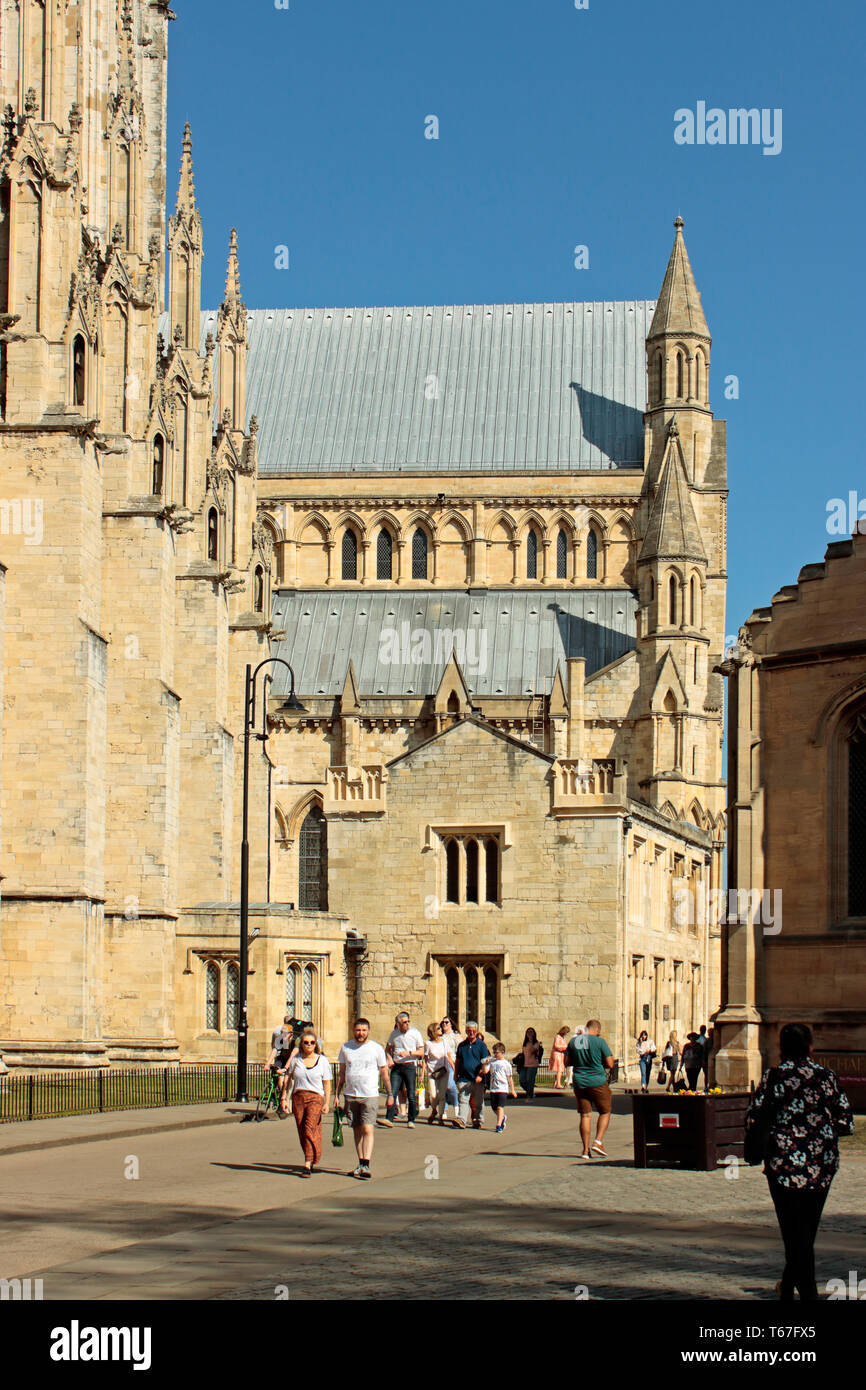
[0,1095,866,1301]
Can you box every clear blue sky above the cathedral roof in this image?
[168,0,866,632]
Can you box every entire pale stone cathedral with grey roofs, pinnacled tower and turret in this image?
[0,0,727,1068]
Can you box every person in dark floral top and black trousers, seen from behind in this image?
[746,1023,853,1302]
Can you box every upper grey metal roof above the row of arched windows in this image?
[202,300,655,475]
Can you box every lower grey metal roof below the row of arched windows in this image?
[271,588,637,698]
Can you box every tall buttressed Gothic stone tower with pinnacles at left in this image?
[0,0,267,1066]
